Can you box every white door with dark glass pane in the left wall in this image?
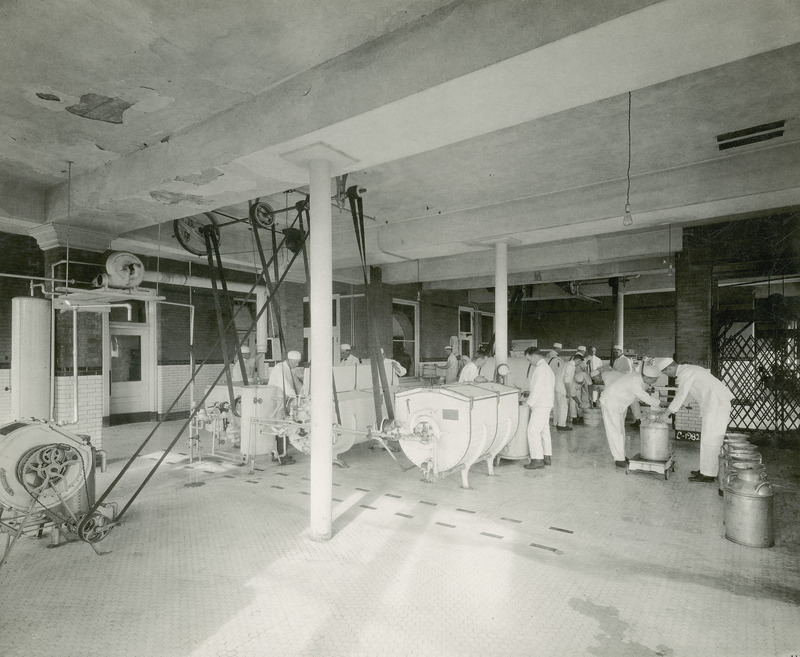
[109,323,150,415]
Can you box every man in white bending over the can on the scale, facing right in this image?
[600,365,661,468]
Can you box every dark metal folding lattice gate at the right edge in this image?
[716,329,800,432]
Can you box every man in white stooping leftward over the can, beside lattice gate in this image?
[653,358,733,483]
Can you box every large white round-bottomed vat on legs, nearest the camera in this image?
[395,383,519,488]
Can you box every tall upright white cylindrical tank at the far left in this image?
[11,297,51,420]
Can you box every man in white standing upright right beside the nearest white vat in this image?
[524,347,556,470]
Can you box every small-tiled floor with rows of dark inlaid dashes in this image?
[0,422,800,657]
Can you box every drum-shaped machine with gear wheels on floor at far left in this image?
[0,420,116,567]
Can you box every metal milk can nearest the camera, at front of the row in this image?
[723,468,775,547]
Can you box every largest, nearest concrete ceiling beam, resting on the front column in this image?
[36,0,800,233]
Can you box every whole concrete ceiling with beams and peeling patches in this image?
[0,0,800,298]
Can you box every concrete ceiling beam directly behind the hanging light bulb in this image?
[375,142,800,259]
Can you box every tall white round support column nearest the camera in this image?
[309,160,333,541]
